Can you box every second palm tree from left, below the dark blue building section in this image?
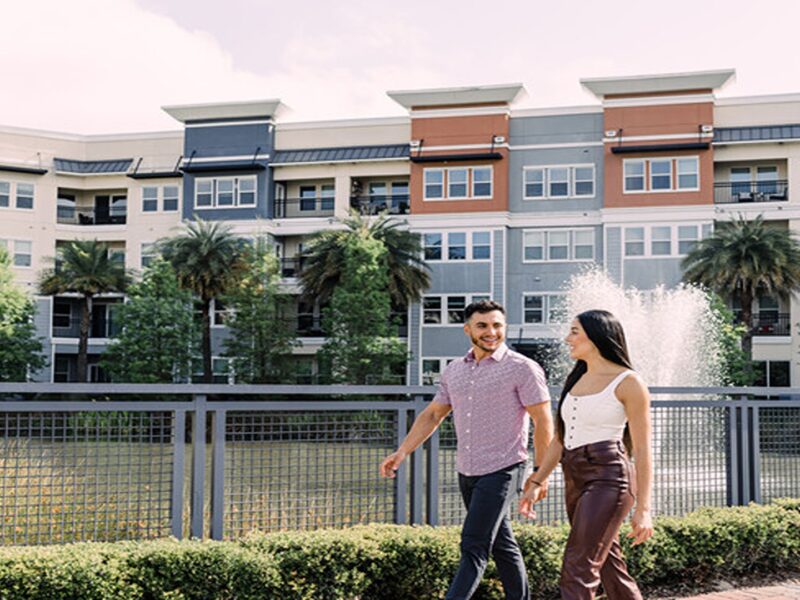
[158,219,246,383]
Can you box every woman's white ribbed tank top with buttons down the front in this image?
[561,370,634,450]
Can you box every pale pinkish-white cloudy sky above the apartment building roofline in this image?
[0,0,800,134]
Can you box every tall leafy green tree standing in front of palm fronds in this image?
[319,228,408,384]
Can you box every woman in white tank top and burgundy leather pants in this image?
[520,310,653,600]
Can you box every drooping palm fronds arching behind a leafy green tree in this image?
[300,212,431,307]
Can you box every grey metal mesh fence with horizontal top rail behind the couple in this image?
[0,384,800,545]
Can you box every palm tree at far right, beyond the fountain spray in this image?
[682,216,800,359]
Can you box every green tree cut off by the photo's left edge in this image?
[0,248,47,381]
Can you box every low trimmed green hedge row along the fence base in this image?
[0,500,800,600]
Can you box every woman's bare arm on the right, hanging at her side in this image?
[617,377,653,546]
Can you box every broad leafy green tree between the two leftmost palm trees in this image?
[101,257,200,383]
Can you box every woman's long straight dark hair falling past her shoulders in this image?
[557,310,633,454]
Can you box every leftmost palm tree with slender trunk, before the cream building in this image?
[39,240,131,383]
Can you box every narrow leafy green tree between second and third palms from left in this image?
[225,237,296,383]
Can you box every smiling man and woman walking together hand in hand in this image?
[381,300,653,600]
